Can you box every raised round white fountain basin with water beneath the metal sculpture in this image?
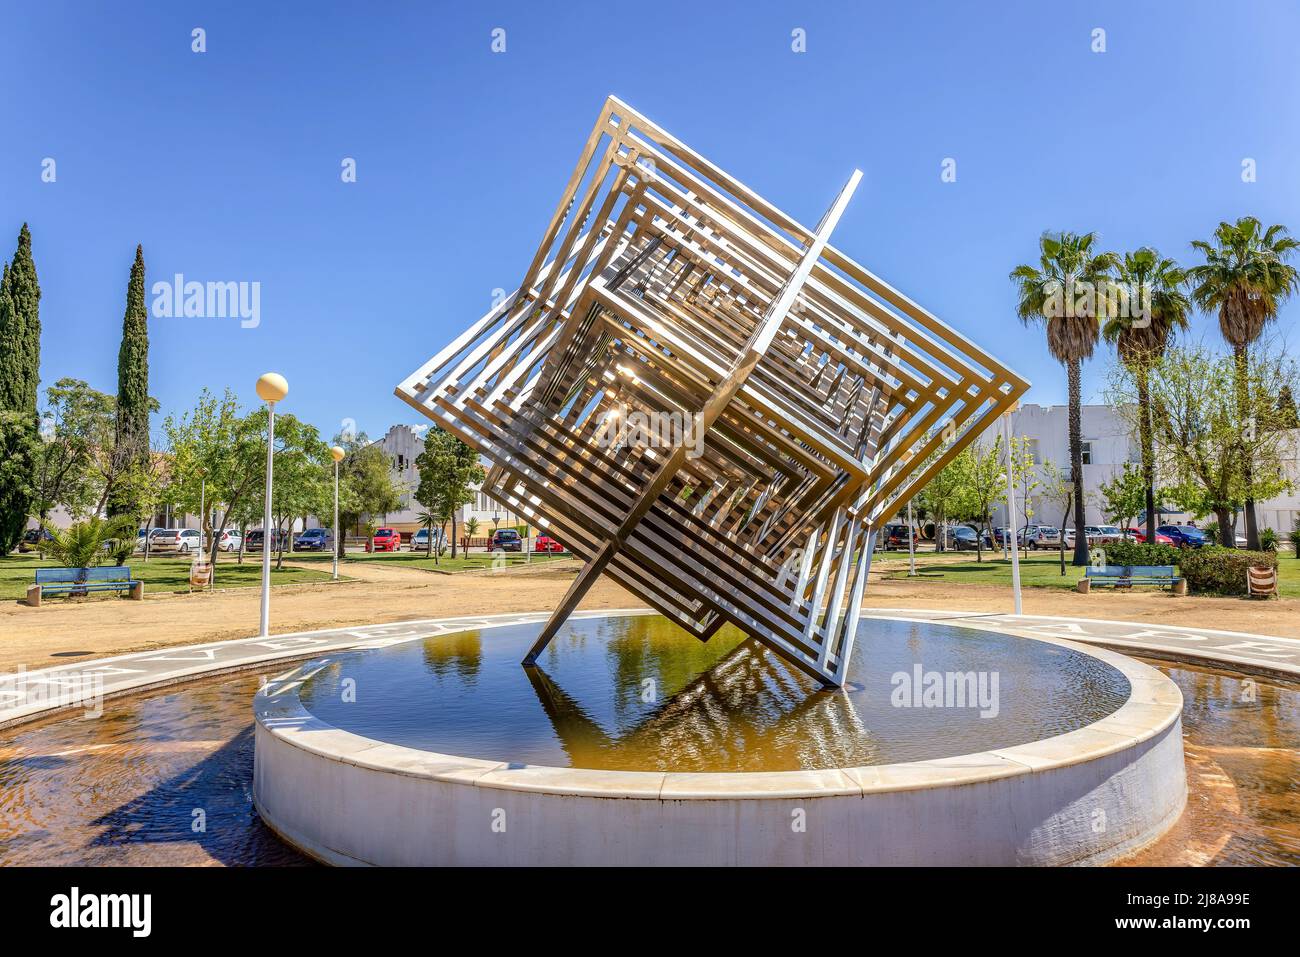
[254,614,1186,865]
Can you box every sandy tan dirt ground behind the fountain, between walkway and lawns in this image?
[0,560,1300,671]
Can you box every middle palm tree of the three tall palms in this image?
[1101,247,1192,541]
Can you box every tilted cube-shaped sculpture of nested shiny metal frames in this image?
[397,96,1028,685]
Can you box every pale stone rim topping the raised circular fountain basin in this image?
[254,610,1183,801]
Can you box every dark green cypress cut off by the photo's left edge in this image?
[0,222,40,554]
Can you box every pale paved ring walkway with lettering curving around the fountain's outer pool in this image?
[0,609,1300,728]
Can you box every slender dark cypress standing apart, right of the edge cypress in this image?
[108,246,150,515]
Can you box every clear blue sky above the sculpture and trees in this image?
[0,0,1300,436]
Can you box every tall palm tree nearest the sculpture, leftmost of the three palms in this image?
[1010,233,1119,566]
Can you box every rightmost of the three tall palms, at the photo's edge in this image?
[1187,216,1300,549]
